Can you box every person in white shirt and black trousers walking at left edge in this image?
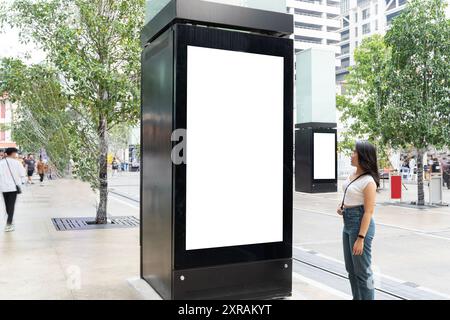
[0,148,25,232]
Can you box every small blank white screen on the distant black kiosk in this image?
[314,132,336,180]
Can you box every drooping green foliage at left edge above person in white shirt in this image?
[0,58,73,174]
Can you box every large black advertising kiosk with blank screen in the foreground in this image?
[141,0,294,299]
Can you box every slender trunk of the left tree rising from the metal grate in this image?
[96,116,108,224]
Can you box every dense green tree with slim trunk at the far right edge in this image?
[385,0,450,205]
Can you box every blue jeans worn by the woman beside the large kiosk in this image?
[342,206,375,300]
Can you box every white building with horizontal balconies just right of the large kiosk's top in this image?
[286,0,341,63]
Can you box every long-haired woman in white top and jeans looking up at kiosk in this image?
[337,141,380,300]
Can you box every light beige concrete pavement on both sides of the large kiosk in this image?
[0,173,450,300]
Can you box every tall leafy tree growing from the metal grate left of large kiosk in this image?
[3,0,145,223]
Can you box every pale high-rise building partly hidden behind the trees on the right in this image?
[336,0,408,86]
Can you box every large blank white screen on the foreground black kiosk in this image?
[186,46,284,250]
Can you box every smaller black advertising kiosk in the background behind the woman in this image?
[295,123,337,193]
